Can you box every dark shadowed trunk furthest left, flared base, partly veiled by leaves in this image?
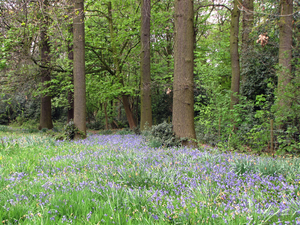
[39,0,53,129]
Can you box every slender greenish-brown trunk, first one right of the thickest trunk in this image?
[230,0,240,109]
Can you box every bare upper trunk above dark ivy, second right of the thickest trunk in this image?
[241,0,254,91]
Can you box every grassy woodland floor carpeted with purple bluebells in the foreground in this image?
[0,135,300,224]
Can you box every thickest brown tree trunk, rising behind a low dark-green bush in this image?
[173,0,196,144]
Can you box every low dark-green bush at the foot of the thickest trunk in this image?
[149,121,181,147]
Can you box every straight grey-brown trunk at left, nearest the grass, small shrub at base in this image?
[73,0,86,139]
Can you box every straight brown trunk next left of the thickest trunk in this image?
[140,0,152,130]
